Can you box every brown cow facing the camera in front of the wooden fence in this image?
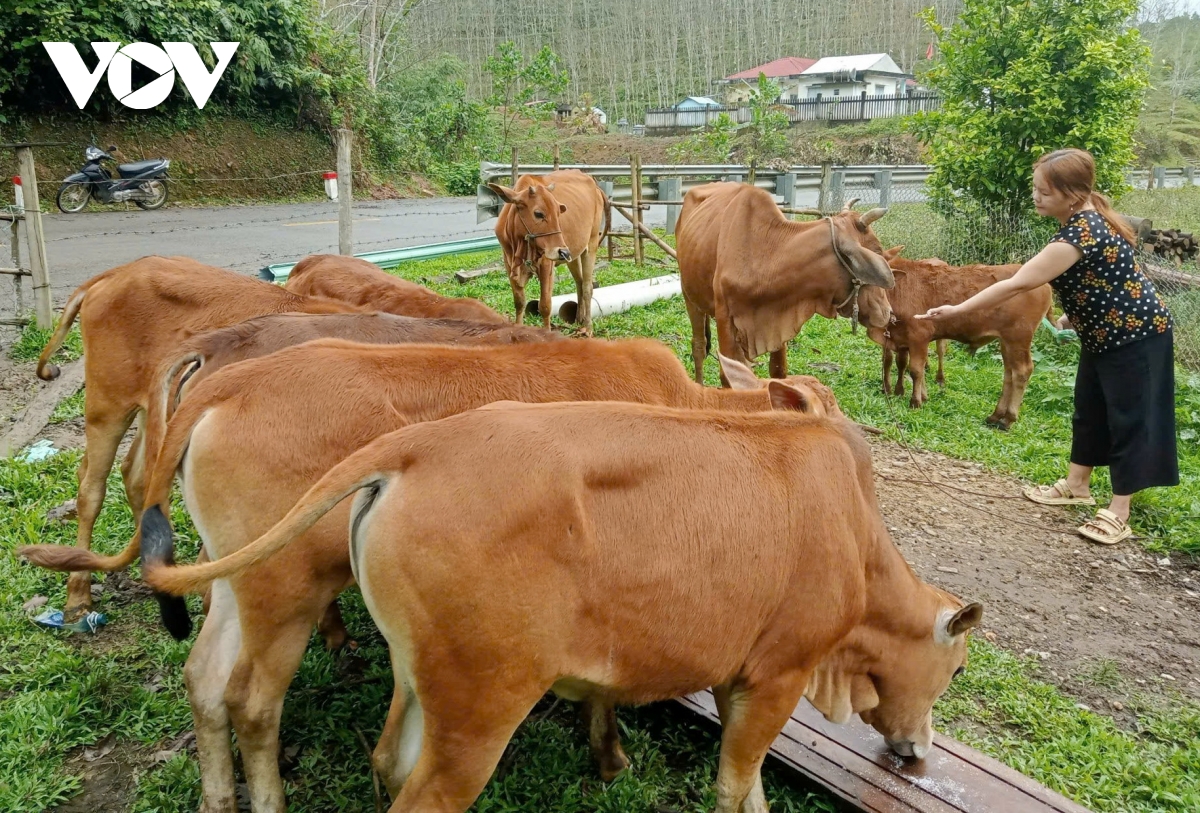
[487,169,610,336]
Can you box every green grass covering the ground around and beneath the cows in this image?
[0,243,1200,813]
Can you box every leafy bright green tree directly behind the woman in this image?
[916,0,1150,216]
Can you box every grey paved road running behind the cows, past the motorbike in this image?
[30,198,664,307]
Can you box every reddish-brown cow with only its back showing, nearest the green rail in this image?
[284,254,508,324]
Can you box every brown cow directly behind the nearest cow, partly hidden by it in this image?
[18,339,840,811]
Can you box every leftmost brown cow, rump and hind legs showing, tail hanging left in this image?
[29,257,355,615]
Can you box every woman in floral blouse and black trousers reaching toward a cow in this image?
[917,149,1180,544]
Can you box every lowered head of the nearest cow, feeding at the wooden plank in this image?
[804,589,983,759]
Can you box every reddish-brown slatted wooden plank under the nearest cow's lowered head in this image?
[679,692,1087,813]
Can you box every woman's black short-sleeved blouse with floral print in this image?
[1050,210,1171,353]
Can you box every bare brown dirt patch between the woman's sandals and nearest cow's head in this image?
[872,441,1200,718]
